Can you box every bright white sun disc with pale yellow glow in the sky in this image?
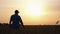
[29,4,42,16]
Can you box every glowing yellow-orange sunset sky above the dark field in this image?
[0,0,60,25]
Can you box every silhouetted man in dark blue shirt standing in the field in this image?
[10,10,23,29]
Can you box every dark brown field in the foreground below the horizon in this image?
[0,24,60,34]
